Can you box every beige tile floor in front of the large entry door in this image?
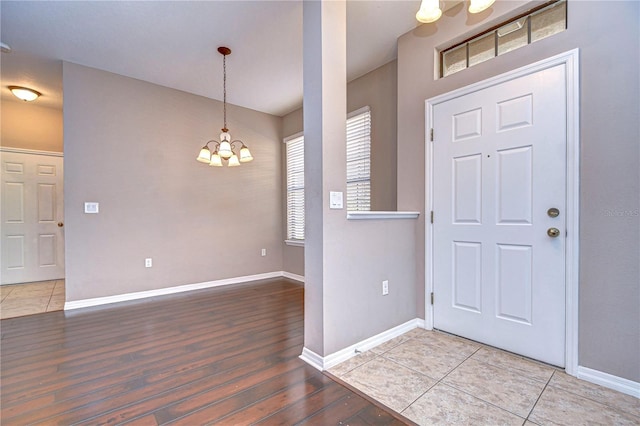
[329,329,640,425]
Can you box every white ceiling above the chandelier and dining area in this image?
[0,0,420,116]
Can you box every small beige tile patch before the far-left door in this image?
[0,280,65,319]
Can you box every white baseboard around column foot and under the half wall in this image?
[300,318,424,371]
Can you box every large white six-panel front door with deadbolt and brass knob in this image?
[432,66,566,366]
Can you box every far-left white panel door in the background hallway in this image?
[0,152,64,284]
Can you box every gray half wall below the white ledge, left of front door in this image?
[322,219,417,356]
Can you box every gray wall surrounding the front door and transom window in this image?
[398,1,640,381]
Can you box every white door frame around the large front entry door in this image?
[425,49,580,376]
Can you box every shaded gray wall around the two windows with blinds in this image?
[282,61,398,275]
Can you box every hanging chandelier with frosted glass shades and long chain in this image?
[196,47,253,167]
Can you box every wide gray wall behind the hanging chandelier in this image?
[63,63,284,301]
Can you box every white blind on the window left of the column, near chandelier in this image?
[284,135,304,241]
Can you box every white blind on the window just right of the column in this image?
[347,106,371,211]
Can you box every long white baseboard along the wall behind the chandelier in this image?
[64,271,304,311]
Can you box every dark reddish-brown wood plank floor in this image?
[0,280,403,426]
